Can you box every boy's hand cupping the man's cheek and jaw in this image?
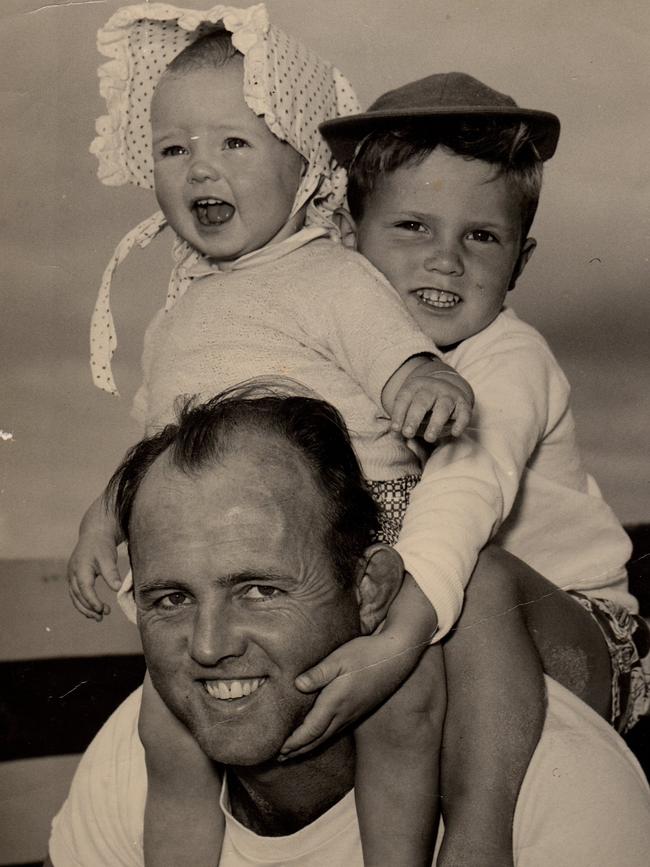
[280,632,423,759]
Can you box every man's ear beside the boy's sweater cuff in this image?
[356,542,404,635]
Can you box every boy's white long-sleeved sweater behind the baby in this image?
[398,310,638,637]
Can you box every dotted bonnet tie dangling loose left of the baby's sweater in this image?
[90,211,167,396]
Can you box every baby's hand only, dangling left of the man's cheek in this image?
[68,532,122,621]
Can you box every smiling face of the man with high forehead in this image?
[130,434,359,765]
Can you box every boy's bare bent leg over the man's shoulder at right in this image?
[439,549,611,867]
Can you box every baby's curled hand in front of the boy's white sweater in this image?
[390,359,474,443]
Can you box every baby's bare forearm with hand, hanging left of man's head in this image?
[68,493,123,621]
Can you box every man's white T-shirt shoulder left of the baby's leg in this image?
[50,689,147,867]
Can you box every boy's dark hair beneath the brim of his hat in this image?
[348,118,543,241]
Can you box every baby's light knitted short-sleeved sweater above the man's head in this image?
[134,238,435,479]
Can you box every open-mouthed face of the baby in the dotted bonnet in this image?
[151,58,303,260]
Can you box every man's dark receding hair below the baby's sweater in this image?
[106,380,378,586]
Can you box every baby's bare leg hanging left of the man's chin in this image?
[138,674,224,867]
